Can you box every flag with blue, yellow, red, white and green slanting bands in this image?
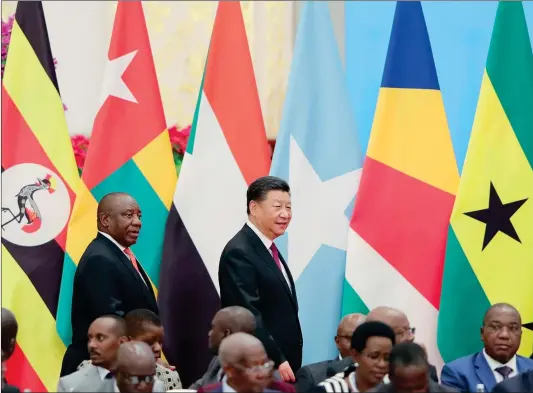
[343,1,459,367]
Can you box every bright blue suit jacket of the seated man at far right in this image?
[440,352,533,392]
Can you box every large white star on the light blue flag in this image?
[287,135,362,281]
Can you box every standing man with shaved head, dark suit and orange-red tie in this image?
[61,193,158,376]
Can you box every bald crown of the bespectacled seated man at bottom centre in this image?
[218,333,266,367]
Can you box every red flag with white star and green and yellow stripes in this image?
[57,1,177,344]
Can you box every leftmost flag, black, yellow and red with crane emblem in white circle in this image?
[1,1,79,392]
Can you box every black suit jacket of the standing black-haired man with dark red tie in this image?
[218,225,303,372]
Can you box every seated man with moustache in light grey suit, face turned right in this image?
[57,315,127,392]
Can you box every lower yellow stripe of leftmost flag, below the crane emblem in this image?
[2,245,66,392]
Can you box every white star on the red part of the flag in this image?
[100,50,138,107]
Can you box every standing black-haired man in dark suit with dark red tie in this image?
[218,176,303,382]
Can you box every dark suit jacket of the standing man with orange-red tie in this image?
[61,233,158,376]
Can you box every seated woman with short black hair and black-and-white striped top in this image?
[316,321,395,393]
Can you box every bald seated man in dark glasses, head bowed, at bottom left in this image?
[81,341,165,393]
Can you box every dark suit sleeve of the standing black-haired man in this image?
[219,249,286,366]
